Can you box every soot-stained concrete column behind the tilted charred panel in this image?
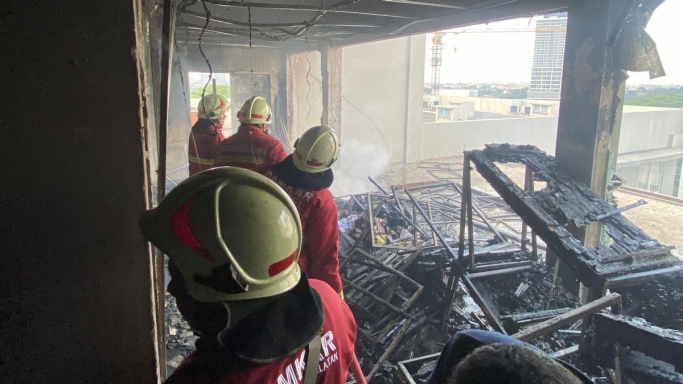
[550,0,630,302]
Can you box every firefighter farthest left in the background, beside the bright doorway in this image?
[187,93,230,176]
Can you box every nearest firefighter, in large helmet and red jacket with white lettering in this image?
[140,167,363,384]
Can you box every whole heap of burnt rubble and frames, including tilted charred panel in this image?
[337,145,683,384]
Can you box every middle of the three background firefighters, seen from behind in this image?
[216,96,287,171]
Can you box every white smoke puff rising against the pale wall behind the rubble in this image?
[330,138,391,196]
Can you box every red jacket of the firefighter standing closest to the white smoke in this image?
[262,156,342,292]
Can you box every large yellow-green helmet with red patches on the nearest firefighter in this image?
[140,167,303,302]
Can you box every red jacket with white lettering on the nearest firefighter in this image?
[165,280,356,384]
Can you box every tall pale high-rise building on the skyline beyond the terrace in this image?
[527,13,567,100]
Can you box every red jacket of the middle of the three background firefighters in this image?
[216,124,287,171]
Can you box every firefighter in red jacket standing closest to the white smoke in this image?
[263,125,344,297]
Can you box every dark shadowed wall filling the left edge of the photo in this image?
[0,0,157,383]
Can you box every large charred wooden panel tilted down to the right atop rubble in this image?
[465,144,677,287]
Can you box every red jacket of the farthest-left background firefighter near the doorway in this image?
[187,119,225,176]
